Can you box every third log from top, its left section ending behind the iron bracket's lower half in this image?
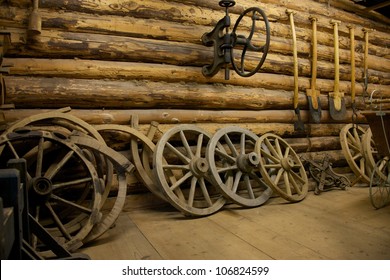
[9,31,390,84]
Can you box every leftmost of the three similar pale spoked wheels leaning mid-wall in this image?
[153,125,225,216]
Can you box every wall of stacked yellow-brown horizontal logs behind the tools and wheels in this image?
[0,0,390,166]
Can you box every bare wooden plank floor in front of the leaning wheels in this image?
[80,187,390,260]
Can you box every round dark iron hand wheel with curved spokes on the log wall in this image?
[231,7,271,77]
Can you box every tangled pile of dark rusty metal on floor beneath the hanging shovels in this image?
[303,155,351,195]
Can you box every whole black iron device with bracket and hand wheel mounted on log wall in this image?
[202,0,270,80]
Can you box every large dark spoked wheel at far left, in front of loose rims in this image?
[0,130,103,251]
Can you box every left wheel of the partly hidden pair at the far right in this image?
[340,124,370,185]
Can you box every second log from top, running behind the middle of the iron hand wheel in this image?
[0,6,390,69]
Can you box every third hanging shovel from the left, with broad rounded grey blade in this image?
[329,20,347,121]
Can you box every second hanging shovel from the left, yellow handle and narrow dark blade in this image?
[306,17,321,123]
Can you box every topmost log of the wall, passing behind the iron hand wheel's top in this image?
[4,0,389,48]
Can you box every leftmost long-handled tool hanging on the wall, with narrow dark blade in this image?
[286,9,305,131]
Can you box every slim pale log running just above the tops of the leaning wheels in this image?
[0,109,366,125]
